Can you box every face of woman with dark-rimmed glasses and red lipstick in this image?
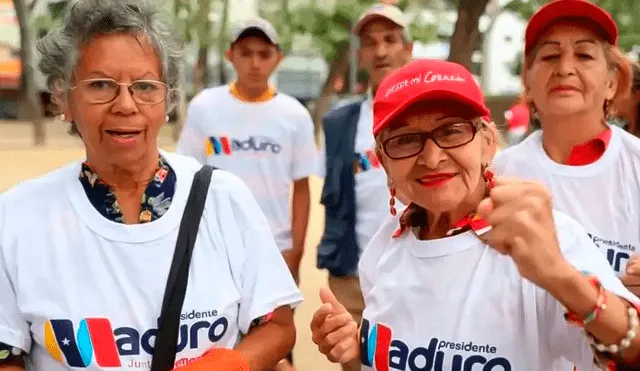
[378,109,496,212]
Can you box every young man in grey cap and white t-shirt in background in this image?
[178,18,318,370]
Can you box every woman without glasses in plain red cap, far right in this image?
[493,0,640,294]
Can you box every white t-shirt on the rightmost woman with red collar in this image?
[492,126,640,275]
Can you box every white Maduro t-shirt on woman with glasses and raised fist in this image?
[360,213,638,371]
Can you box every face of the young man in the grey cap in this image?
[227,36,283,89]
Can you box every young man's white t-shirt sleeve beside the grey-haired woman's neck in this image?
[176,102,207,164]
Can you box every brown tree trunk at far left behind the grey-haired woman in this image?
[13,0,46,146]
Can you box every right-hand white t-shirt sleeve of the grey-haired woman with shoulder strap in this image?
[214,170,302,334]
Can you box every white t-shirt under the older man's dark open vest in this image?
[318,98,392,254]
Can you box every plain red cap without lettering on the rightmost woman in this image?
[524,0,618,54]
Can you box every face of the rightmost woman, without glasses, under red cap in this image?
[525,23,617,117]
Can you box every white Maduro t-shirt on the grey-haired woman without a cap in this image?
[0,152,302,371]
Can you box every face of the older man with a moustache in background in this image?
[358,18,413,91]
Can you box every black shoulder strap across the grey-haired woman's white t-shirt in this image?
[151,165,215,371]
